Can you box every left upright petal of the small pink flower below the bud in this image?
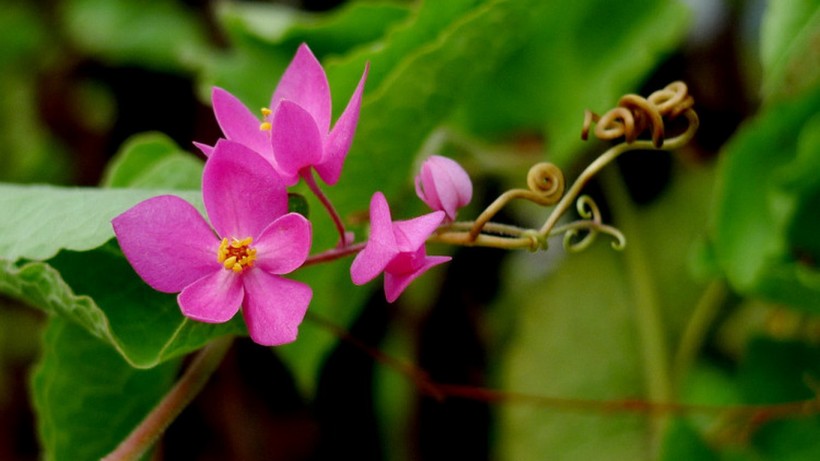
[350,192,399,285]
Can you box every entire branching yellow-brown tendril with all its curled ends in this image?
[430,82,699,252]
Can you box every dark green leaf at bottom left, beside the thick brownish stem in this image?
[31,317,179,460]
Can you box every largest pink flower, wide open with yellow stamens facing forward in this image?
[112,140,313,345]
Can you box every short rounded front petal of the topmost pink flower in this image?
[271,100,322,186]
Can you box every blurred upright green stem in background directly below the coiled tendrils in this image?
[602,170,672,452]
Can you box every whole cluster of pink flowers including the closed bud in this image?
[112,44,472,345]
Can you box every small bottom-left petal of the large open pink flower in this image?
[177,268,245,323]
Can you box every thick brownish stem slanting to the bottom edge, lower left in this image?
[102,336,233,461]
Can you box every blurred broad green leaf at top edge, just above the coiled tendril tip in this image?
[452,0,689,166]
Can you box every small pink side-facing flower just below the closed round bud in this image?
[350,192,452,303]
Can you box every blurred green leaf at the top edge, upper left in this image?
[59,0,208,71]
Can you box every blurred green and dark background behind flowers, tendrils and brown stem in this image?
[0,0,820,460]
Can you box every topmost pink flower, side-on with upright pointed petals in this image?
[197,44,368,186]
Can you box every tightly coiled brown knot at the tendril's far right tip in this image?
[581,81,695,148]
